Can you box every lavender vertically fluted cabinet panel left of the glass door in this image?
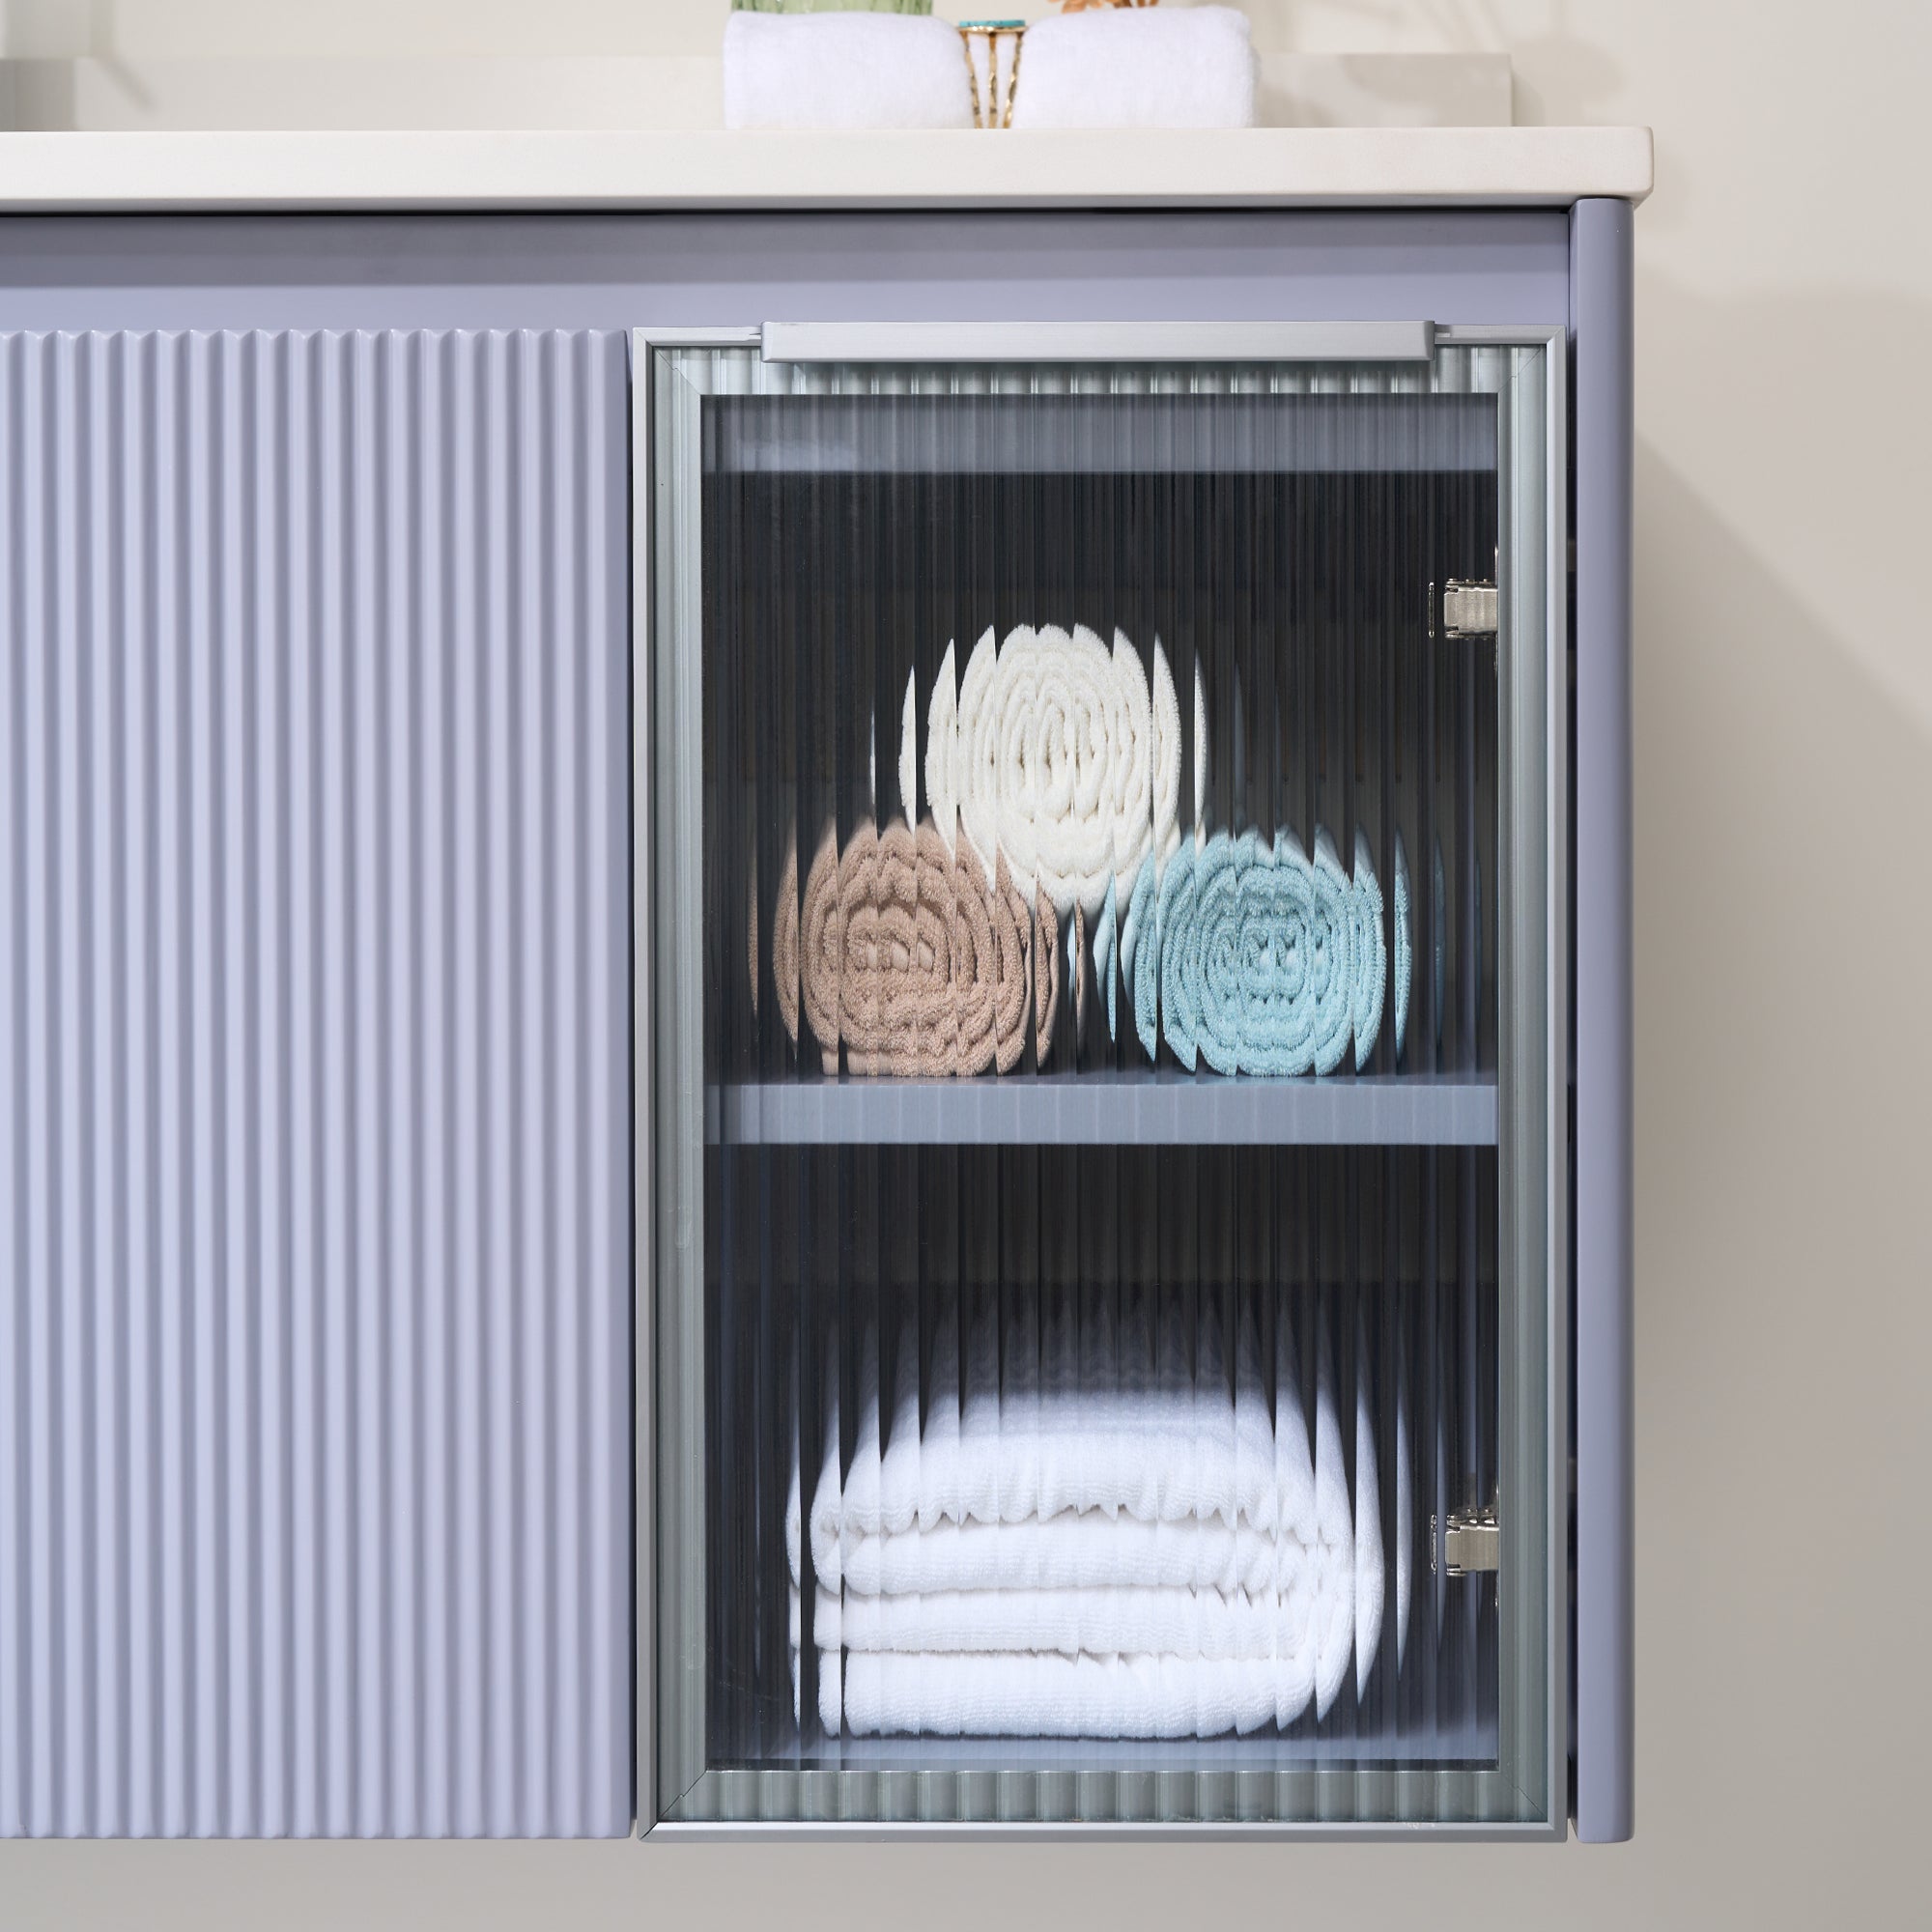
[0,332,632,1835]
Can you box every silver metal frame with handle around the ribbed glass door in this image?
[632,323,1573,1839]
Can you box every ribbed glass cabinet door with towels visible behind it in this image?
[639,328,1567,1828]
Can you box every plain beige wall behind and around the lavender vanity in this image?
[0,0,1932,1932]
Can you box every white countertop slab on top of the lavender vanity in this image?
[0,128,1652,213]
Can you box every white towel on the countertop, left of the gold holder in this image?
[724,14,972,128]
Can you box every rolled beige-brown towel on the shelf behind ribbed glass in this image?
[773,819,1061,1078]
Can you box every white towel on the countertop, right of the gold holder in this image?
[1012,6,1254,128]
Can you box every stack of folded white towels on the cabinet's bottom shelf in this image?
[786,1291,1406,1739]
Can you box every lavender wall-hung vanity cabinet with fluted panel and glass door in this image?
[0,162,1648,1839]
